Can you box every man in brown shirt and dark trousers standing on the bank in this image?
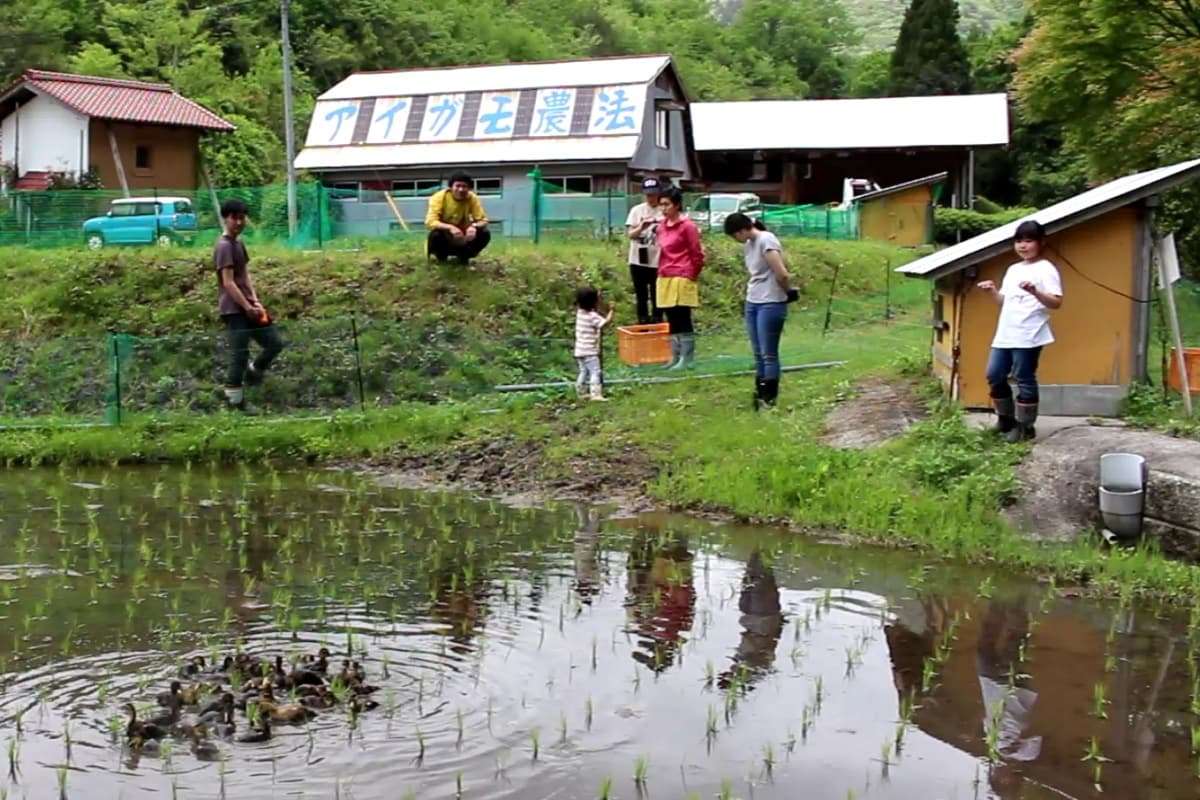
[212,198,283,414]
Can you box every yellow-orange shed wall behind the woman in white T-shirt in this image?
[934,207,1140,408]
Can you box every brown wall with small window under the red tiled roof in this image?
[90,120,199,191]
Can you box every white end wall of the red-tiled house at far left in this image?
[0,96,89,176]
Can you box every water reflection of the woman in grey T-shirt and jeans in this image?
[718,549,784,688]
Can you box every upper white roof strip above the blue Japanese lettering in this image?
[318,55,671,100]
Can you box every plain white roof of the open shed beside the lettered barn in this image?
[691,94,1008,151]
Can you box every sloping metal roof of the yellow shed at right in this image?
[896,158,1200,278]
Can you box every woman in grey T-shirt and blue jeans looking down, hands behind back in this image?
[725,213,798,410]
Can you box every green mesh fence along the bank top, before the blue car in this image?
[0,181,858,249]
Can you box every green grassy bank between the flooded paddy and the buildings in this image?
[0,235,1200,601]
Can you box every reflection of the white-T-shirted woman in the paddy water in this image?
[976,601,1042,762]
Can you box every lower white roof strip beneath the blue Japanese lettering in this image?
[296,136,640,169]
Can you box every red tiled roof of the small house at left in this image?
[4,70,234,131]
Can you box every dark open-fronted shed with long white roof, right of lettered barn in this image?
[691,94,1009,207]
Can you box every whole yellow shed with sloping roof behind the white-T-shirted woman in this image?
[898,160,1200,416]
